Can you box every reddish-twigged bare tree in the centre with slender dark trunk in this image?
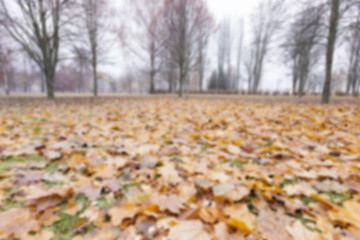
[163,0,212,97]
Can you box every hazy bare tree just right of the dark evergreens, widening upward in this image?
[251,0,284,93]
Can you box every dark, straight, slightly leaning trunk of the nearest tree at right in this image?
[322,0,340,104]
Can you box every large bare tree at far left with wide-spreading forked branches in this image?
[0,0,71,98]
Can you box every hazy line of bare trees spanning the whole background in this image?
[0,0,360,103]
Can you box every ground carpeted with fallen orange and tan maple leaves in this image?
[0,99,360,240]
